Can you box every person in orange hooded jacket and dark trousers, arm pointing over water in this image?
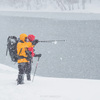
[17,33,38,84]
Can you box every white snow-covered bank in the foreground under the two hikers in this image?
[0,64,100,100]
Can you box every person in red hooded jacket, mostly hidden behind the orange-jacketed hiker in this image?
[27,34,41,81]
